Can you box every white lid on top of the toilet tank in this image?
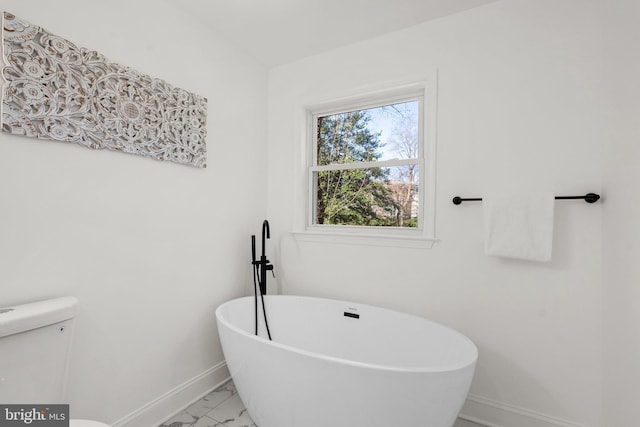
[0,297,78,338]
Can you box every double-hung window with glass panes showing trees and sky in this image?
[306,82,435,247]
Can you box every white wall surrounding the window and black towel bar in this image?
[269,0,605,426]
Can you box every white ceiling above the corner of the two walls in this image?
[180,0,496,67]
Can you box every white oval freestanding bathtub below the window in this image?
[216,295,478,427]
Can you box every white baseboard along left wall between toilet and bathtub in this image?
[113,362,230,427]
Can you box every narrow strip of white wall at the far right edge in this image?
[602,0,640,426]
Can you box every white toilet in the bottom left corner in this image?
[0,297,109,427]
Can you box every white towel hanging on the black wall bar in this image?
[482,193,555,261]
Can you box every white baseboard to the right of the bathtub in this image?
[458,394,586,427]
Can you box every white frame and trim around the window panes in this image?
[294,79,437,248]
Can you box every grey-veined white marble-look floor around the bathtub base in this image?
[159,380,481,427]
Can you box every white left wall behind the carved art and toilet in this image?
[0,0,267,422]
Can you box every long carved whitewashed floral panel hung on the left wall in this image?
[2,12,207,167]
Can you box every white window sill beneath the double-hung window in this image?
[291,230,438,249]
